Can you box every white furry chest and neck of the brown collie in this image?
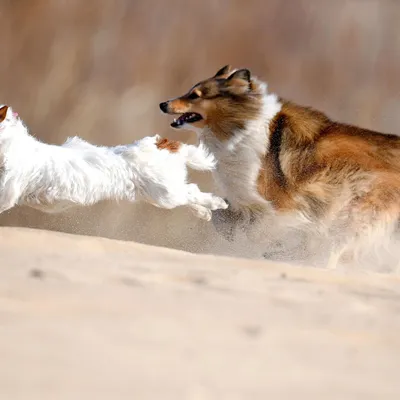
[199,90,282,208]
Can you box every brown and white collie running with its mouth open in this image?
[160,66,400,265]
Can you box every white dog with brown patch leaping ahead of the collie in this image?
[0,106,227,220]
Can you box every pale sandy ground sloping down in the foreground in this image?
[0,228,400,400]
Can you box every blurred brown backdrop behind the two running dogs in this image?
[0,0,400,252]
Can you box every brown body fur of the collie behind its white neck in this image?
[257,102,400,222]
